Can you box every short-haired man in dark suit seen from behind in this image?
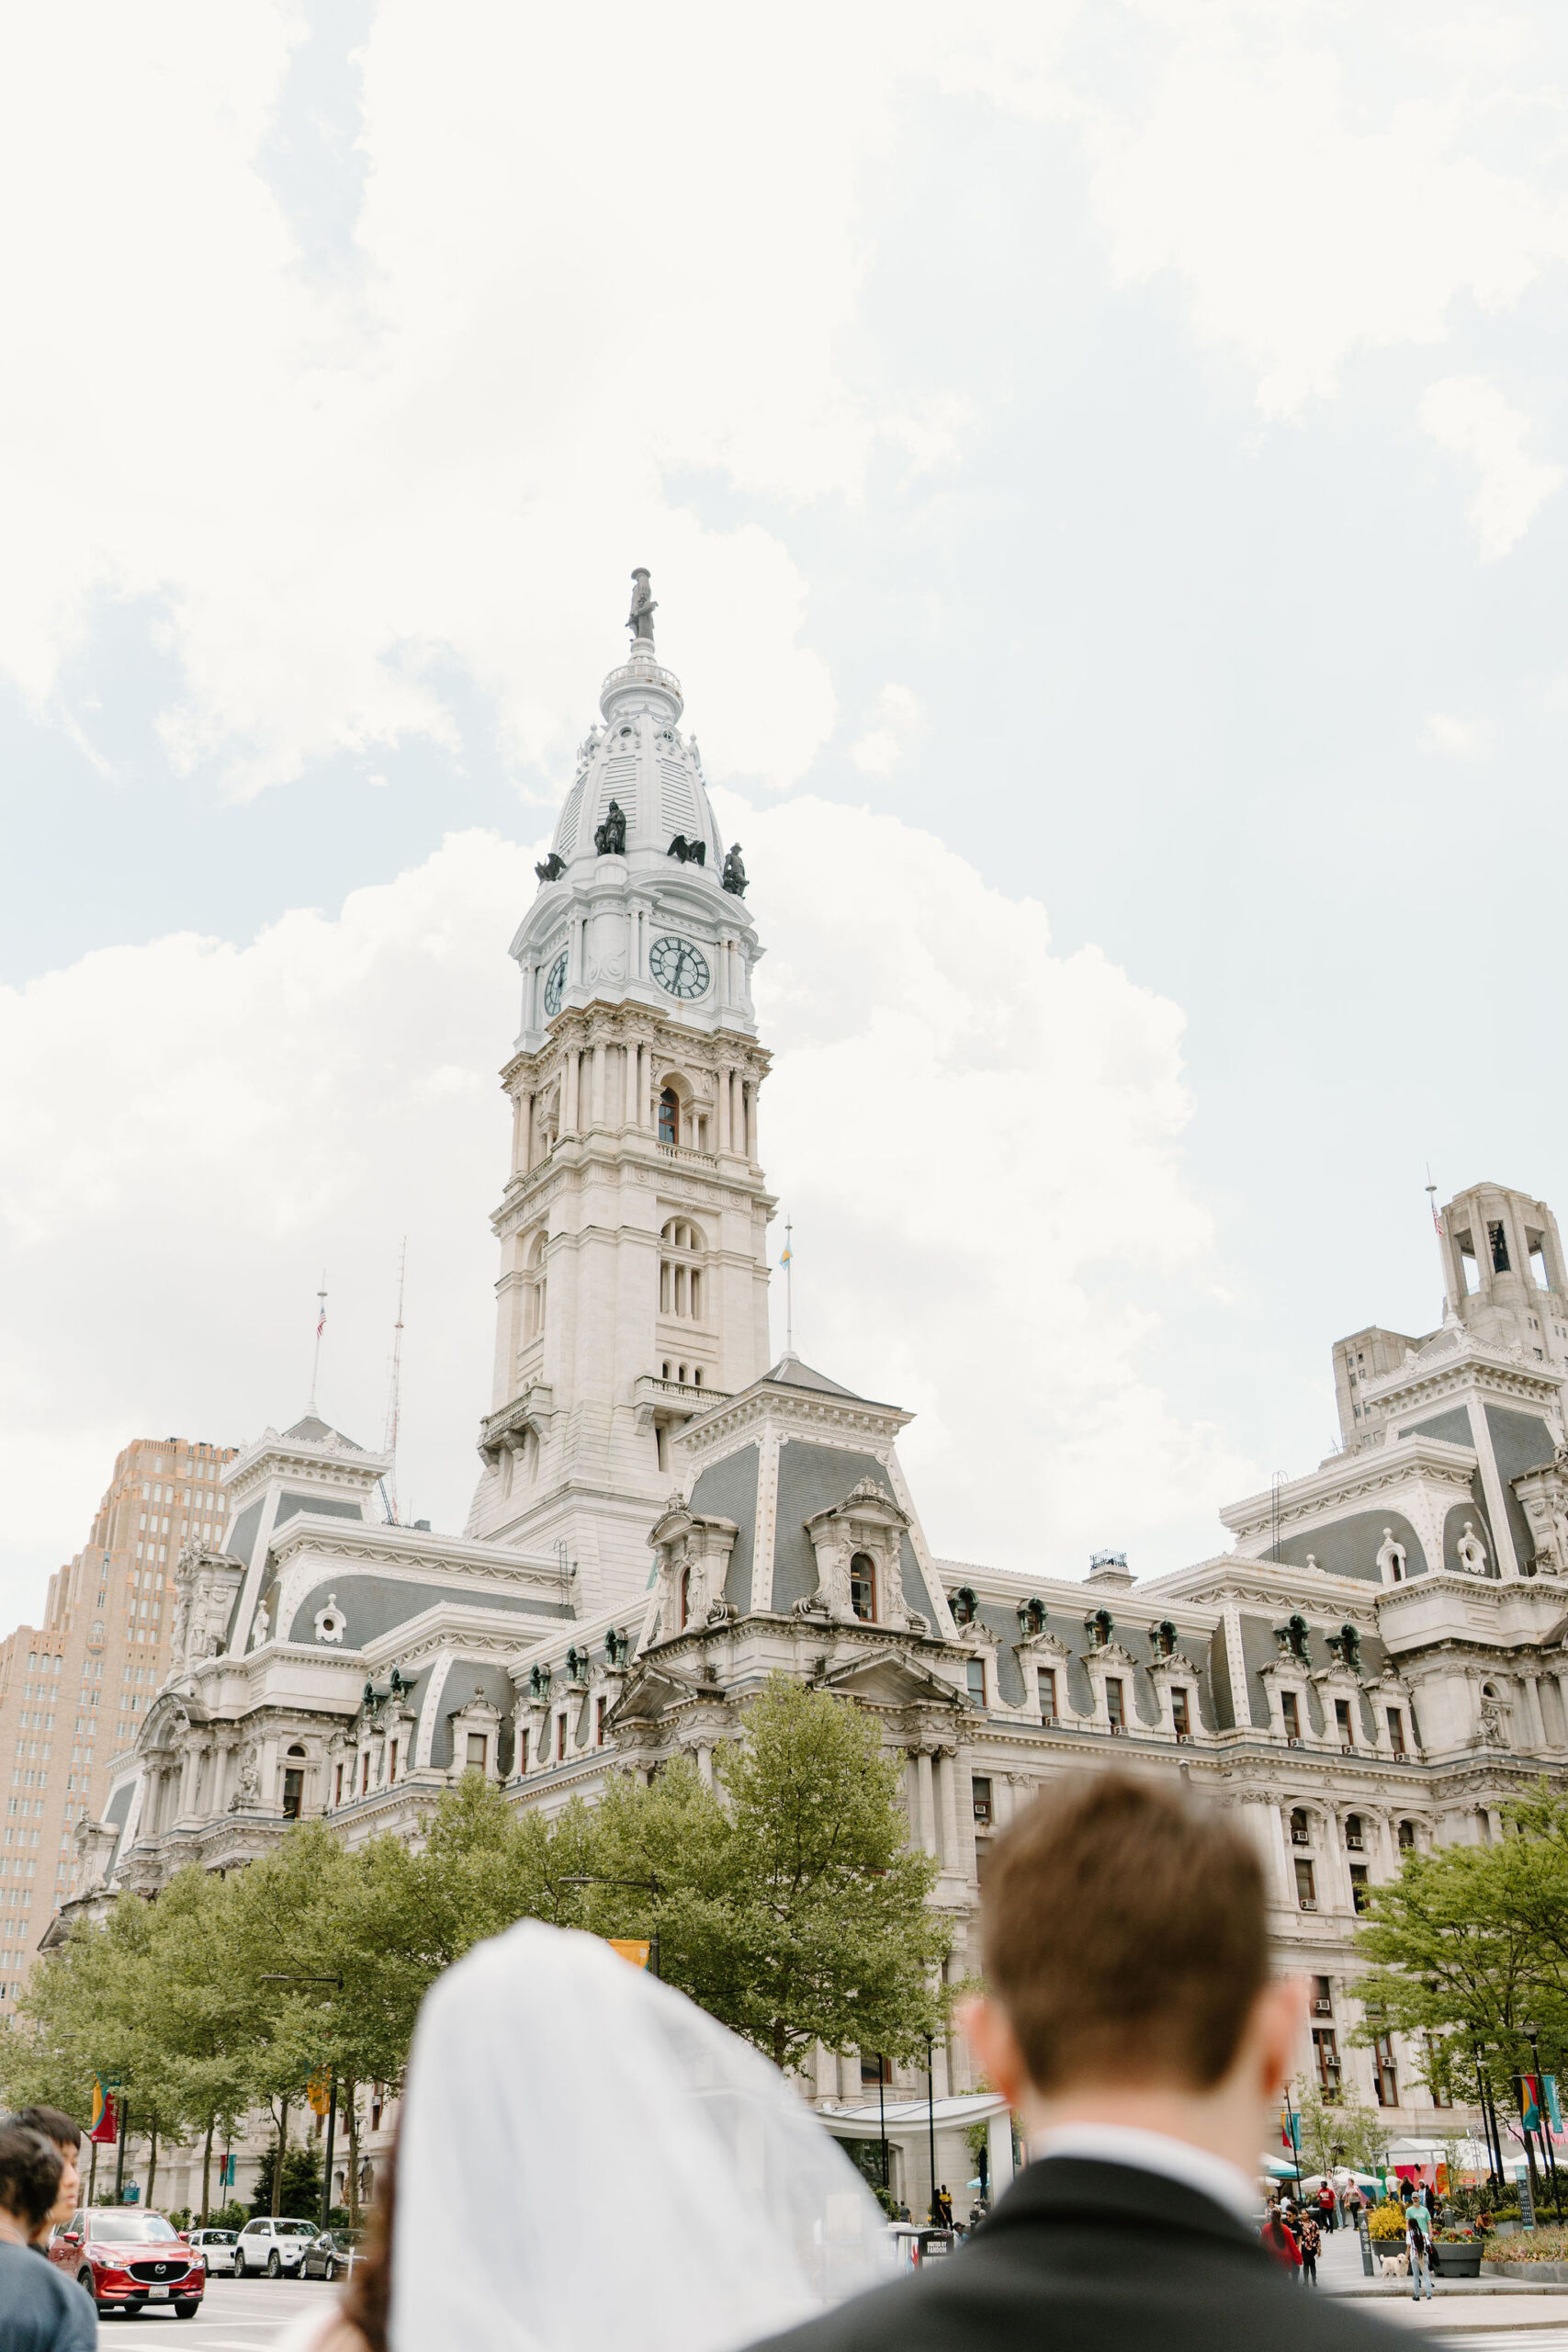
[751,1773,1396,2352]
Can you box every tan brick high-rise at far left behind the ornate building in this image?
[0,1437,235,2016]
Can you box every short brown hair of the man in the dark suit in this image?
[983,1773,1269,2091]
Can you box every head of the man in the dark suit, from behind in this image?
[968,1773,1300,2164]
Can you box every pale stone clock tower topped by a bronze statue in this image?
[470,571,773,1613]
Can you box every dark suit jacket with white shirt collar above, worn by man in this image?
[751,2157,1396,2352]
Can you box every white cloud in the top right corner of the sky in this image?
[1081,5,1568,416]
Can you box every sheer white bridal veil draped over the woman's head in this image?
[390,1919,886,2352]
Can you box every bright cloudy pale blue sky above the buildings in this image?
[0,0,1568,1623]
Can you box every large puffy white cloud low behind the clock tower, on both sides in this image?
[0,799,1253,1609]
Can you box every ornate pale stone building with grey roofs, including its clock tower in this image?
[51,574,1568,2188]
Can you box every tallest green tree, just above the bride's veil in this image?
[588,1675,952,2067]
